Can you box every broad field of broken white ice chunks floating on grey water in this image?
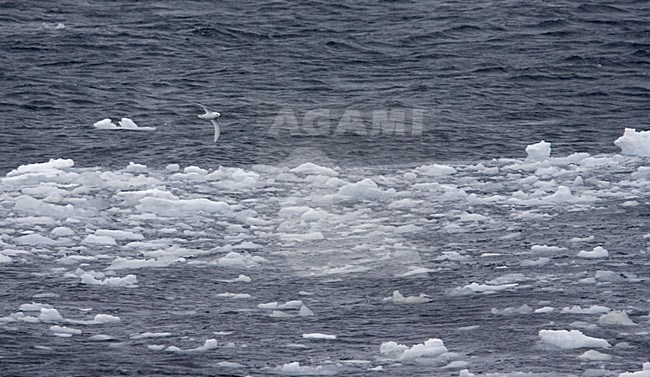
[0,128,650,376]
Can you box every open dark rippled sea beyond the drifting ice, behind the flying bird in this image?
[0,1,649,170]
